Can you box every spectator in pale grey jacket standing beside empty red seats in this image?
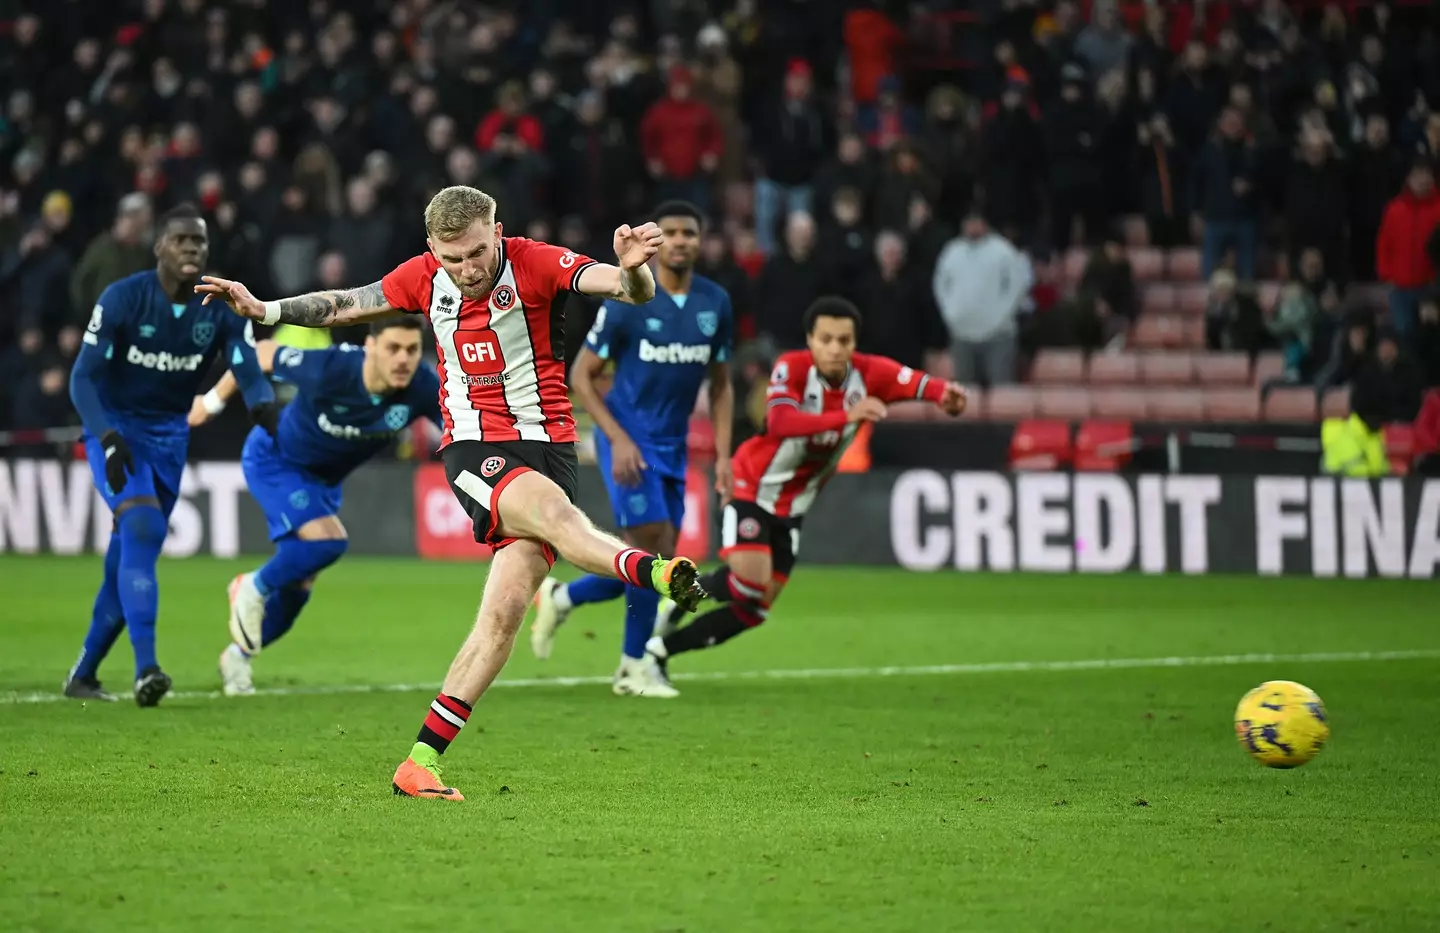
[933,212,1034,386]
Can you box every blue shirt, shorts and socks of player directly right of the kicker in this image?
[560,275,734,658]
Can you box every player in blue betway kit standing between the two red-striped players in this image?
[530,202,734,697]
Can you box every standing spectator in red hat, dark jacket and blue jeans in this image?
[753,59,835,253]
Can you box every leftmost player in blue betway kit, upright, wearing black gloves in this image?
[65,204,276,707]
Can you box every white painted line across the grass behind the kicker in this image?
[0,648,1440,706]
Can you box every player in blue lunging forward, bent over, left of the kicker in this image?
[190,317,441,697]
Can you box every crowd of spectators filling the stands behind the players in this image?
[0,0,1440,449]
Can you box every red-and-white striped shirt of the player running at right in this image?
[733,350,945,518]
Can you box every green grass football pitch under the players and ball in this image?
[0,559,1440,933]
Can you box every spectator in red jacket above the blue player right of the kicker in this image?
[639,65,724,210]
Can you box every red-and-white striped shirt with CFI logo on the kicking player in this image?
[380,236,595,446]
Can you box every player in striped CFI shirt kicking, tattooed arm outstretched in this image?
[196,186,704,801]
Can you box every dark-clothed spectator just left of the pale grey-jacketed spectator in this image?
[857,230,949,370]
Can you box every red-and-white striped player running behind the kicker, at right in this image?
[645,298,966,664]
